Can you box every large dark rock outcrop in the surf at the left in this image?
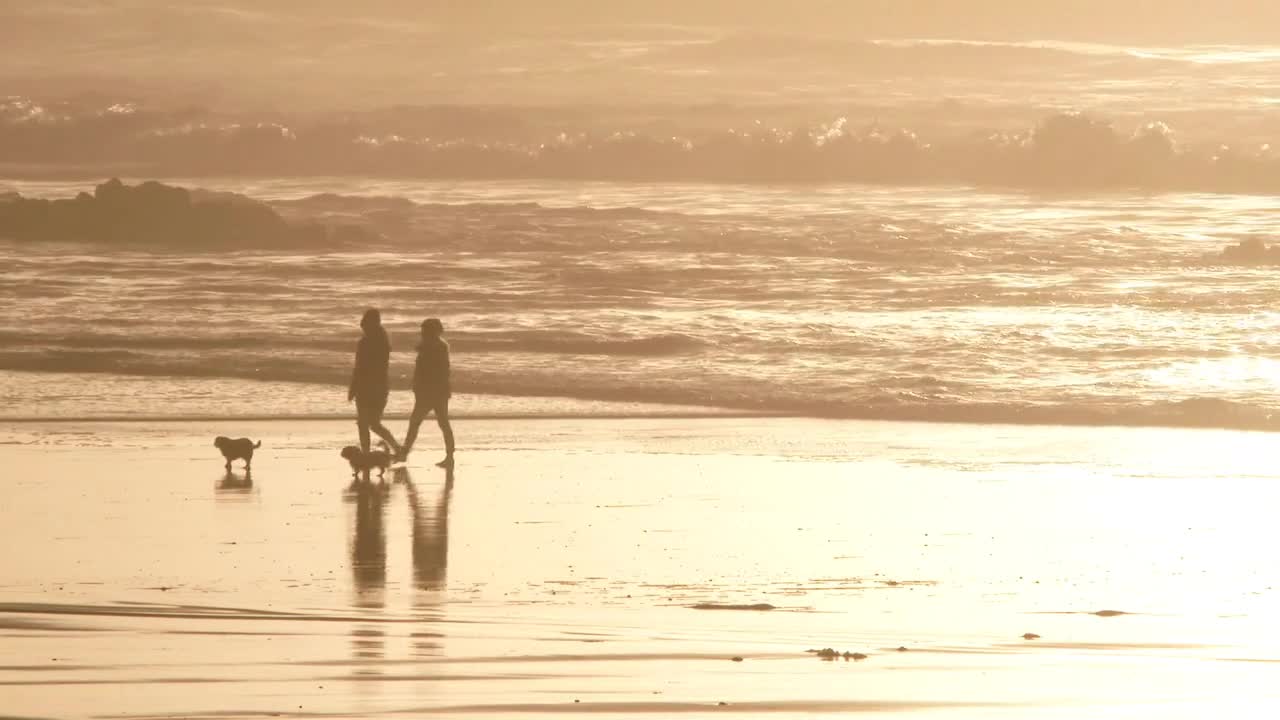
[0,179,376,250]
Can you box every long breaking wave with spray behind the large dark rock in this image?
[0,100,1280,193]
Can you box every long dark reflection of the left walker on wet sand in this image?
[347,480,388,675]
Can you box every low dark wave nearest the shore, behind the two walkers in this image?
[0,350,1280,432]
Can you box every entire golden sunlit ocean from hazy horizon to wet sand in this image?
[0,18,1280,429]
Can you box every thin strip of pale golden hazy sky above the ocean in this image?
[0,0,1280,44]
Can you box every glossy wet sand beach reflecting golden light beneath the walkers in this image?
[0,419,1280,719]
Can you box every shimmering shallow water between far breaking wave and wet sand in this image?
[0,178,1280,428]
